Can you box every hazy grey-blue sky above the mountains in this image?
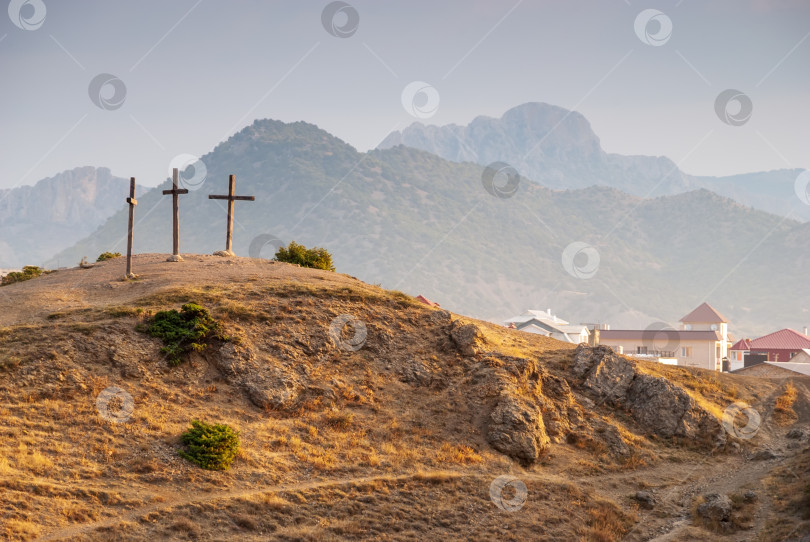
[0,0,810,188]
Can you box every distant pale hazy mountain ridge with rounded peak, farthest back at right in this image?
[379,102,810,221]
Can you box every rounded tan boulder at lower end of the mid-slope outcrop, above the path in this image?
[487,395,550,464]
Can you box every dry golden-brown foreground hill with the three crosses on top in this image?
[0,254,810,541]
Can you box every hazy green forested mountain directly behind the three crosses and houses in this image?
[45,120,810,336]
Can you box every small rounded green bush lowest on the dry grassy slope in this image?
[179,420,239,470]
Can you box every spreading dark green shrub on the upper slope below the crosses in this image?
[146,303,230,365]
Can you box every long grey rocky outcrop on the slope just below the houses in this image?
[572,346,726,446]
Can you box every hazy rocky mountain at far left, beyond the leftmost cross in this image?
[0,166,143,268]
